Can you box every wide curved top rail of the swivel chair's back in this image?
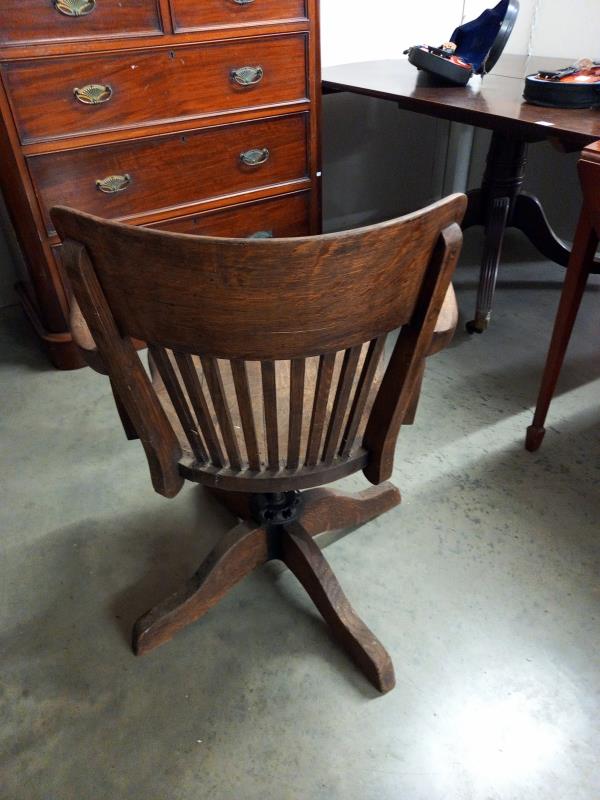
[53,194,465,360]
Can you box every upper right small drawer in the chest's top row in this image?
[171,0,306,32]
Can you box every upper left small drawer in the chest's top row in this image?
[0,0,162,45]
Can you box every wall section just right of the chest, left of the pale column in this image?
[321,0,463,230]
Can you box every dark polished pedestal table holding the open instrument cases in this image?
[323,55,600,333]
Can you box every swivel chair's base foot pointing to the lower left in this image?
[132,522,269,655]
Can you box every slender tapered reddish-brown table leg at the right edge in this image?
[525,213,598,452]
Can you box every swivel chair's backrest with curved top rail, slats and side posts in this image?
[52,195,465,495]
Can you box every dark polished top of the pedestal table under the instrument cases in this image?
[322,55,600,148]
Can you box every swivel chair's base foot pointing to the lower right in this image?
[281,522,396,693]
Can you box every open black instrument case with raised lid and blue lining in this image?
[405,0,519,86]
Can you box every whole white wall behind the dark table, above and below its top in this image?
[321,0,600,238]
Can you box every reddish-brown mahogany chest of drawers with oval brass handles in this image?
[0,0,320,368]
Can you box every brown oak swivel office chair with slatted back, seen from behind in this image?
[52,195,465,692]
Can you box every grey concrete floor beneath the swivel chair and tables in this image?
[0,231,600,800]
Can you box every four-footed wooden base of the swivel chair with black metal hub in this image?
[133,483,400,692]
